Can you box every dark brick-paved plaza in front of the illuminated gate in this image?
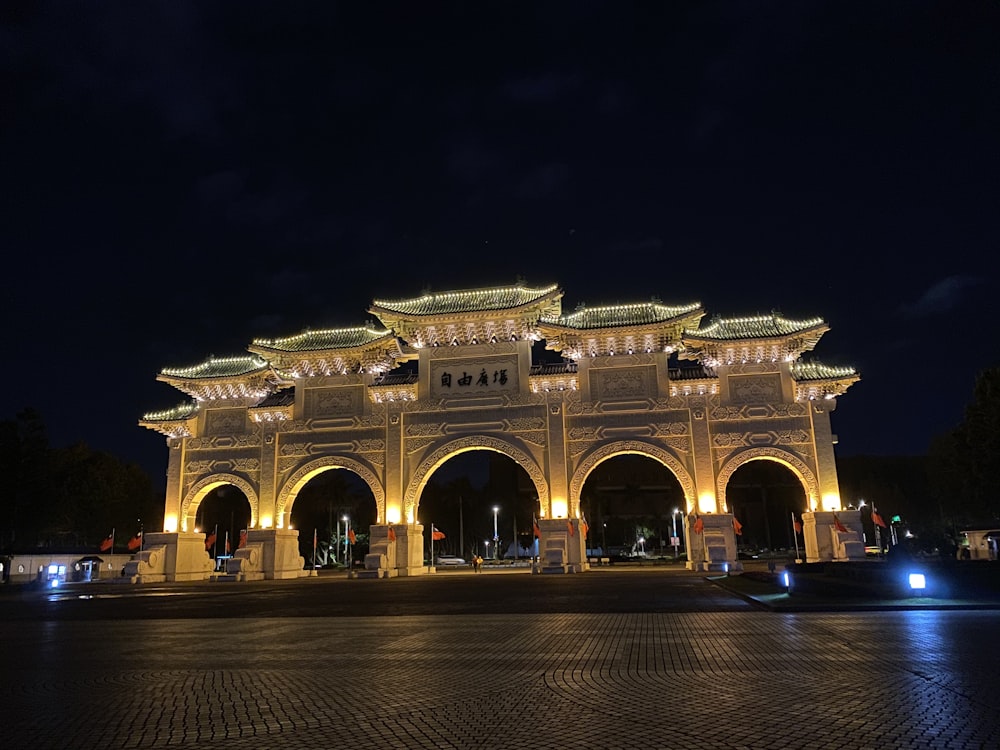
[0,571,1000,750]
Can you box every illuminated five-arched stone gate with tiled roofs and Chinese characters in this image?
[132,283,864,580]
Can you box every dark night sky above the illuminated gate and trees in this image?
[0,0,1000,494]
